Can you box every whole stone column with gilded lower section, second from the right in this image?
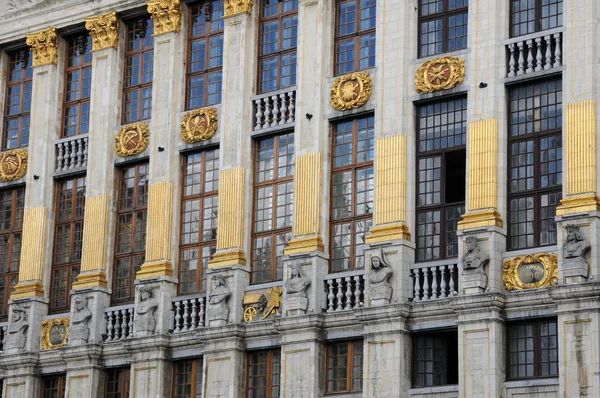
[458,0,509,294]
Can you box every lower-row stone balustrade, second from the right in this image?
[325,270,365,313]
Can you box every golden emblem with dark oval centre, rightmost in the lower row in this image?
[502,253,558,291]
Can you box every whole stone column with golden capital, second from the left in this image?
[69,11,124,346]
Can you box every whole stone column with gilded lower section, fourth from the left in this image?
[207,0,258,326]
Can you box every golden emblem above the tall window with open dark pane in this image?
[415,57,465,93]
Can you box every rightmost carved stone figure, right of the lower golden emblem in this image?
[561,224,590,283]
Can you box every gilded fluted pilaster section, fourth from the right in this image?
[285,152,324,255]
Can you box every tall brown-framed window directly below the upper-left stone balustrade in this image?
[50,177,85,311]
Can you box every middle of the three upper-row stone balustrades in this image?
[252,87,296,131]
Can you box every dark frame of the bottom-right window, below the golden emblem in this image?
[506,318,560,381]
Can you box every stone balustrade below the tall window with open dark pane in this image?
[410,263,458,302]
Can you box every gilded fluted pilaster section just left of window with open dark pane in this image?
[367,135,411,244]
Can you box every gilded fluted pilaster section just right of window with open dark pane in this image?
[458,118,503,230]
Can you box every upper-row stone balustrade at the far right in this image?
[505,28,562,77]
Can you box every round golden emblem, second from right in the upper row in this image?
[329,72,373,111]
